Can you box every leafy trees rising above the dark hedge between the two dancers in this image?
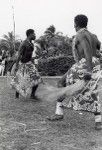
[36,25,72,58]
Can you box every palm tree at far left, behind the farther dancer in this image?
[0,32,21,57]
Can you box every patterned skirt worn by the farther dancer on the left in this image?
[11,61,41,97]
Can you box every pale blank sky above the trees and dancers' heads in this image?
[0,0,102,41]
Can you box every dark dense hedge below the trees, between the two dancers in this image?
[38,55,74,76]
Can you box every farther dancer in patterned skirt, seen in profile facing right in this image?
[12,29,41,99]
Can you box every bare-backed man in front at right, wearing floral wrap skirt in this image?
[48,15,102,129]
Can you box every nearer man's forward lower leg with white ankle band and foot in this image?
[47,95,65,121]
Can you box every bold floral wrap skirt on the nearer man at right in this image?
[66,57,101,112]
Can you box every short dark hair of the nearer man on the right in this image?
[74,14,88,28]
